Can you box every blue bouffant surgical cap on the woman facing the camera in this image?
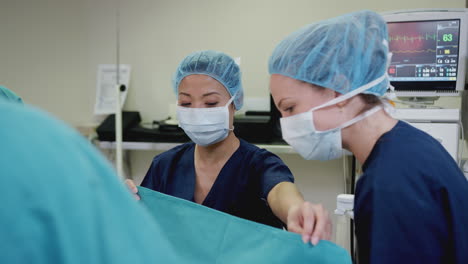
[172,50,244,110]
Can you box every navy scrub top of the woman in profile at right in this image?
[354,121,468,264]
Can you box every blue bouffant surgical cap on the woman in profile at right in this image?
[269,11,389,96]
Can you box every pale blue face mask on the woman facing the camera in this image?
[177,95,236,146]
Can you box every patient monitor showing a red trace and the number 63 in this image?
[382,9,468,97]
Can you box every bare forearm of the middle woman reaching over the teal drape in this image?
[267,182,304,224]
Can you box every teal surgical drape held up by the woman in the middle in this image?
[138,187,351,264]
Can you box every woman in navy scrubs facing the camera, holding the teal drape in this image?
[127,50,331,244]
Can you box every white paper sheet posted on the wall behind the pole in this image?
[94,64,131,115]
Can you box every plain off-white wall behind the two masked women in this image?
[0,0,465,244]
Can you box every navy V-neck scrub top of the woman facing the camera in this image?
[141,139,294,228]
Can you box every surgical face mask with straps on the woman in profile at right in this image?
[280,59,388,160]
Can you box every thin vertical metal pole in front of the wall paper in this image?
[115,0,125,180]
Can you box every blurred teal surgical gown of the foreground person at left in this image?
[0,98,177,264]
